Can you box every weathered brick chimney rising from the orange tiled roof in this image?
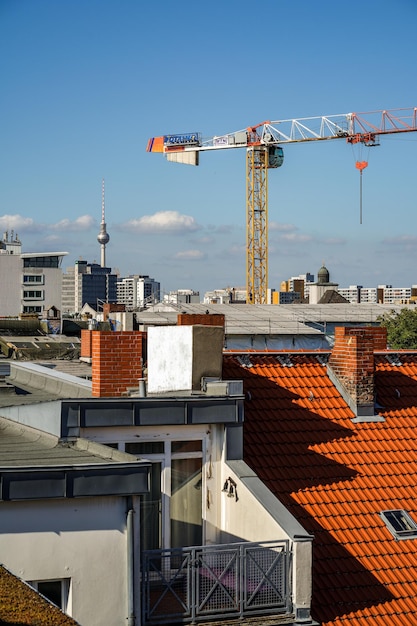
[328,326,387,421]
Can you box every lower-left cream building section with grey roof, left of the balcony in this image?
[0,408,149,626]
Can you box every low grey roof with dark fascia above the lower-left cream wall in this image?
[0,416,150,501]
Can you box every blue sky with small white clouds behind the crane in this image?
[0,0,417,293]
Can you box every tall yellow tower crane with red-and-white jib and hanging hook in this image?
[147,107,417,304]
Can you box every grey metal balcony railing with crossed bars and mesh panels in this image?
[142,541,291,625]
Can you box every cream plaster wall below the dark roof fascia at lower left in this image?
[0,497,140,626]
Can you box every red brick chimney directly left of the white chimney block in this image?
[88,330,146,398]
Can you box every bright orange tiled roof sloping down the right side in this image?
[223,353,417,626]
